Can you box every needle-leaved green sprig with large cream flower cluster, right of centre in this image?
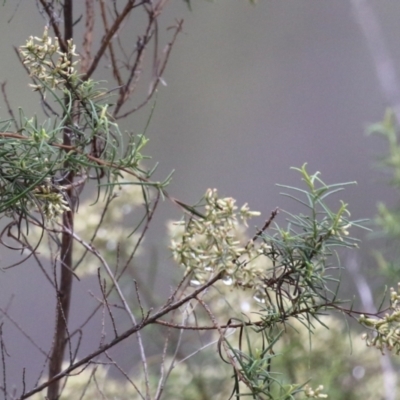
[171,165,361,399]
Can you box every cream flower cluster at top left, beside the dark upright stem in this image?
[20,27,78,93]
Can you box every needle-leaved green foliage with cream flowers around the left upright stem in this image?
[0,29,161,225]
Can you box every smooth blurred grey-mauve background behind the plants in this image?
[0,0,400,394]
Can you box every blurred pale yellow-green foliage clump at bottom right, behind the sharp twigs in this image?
[277,316,383,400]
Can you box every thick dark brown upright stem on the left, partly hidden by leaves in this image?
[47,0,76,400]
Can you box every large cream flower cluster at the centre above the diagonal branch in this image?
[170,189,268,292]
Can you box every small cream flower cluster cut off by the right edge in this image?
[358,283,400,355]
